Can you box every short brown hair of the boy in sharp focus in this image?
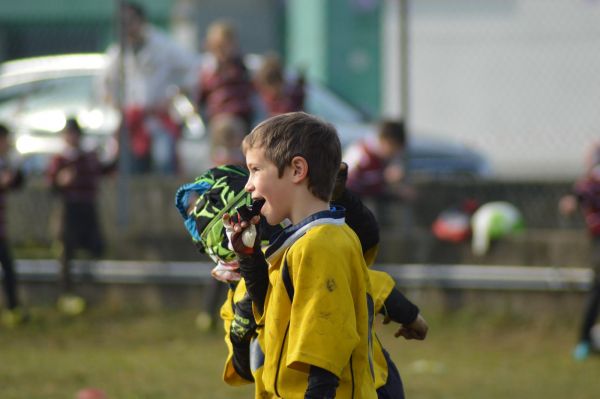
[243,112,342,201]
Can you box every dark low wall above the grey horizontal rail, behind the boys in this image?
[3,177,587,266]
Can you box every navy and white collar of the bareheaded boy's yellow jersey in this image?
[265,206,346,260]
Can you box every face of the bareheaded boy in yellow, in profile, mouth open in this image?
[245,148,292,226]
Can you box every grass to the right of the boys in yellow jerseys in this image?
[380,309,600,399]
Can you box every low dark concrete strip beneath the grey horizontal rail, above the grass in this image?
[11,281,585,322]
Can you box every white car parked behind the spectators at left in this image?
[0,54,208,174]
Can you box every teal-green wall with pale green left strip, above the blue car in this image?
[286,0,381,117]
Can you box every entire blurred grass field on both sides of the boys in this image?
[0,308,600,399]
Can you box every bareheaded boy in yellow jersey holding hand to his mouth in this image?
[224,112,377,399]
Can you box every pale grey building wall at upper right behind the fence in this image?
[409,0,600,181]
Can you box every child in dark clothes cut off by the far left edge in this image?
[0,124,25,326]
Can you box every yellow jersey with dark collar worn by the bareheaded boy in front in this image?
[258,210,377,399]
